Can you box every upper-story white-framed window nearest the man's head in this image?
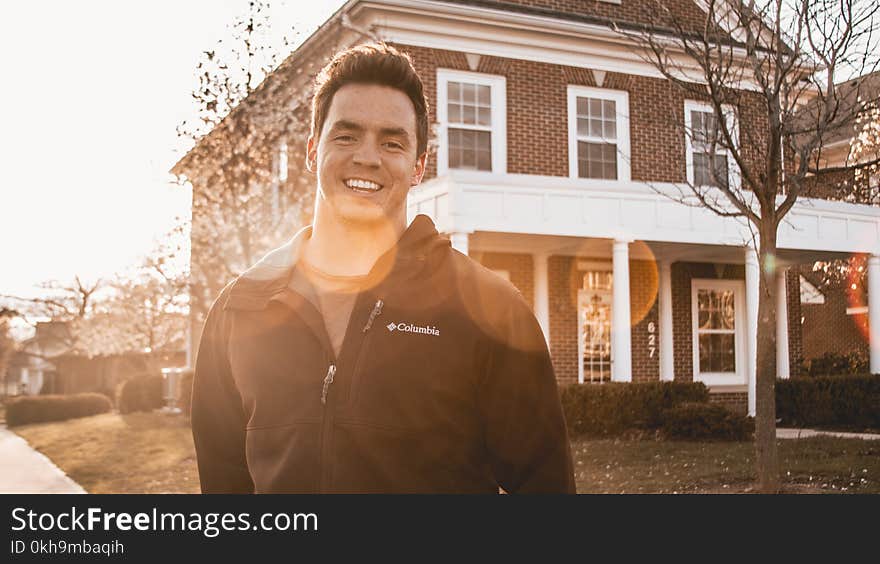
[437,69,507,174]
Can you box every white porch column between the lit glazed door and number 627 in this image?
[611,239,632,382]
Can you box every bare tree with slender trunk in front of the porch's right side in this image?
[615,0,878,492]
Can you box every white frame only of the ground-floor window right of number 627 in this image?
[691,278,748,386]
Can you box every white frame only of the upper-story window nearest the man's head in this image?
[437,69,507,176]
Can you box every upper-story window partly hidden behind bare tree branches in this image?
[684,100,738,187]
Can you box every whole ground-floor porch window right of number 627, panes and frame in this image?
[692,280,746,385]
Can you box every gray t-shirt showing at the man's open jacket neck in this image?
[289,259,367,357]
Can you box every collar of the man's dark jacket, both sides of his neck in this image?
[223,215,449,310]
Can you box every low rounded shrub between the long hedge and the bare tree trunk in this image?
[660,403,755,441]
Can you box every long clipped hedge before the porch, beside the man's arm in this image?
[560,382,709,437]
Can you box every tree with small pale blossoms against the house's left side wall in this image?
[173,1,322,324]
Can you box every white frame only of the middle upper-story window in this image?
[568,84,632,182]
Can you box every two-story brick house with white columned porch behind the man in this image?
[175,0,880,413]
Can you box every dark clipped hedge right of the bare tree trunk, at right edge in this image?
[776,375,880,429]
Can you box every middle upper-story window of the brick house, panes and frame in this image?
[568,86,630,180]
